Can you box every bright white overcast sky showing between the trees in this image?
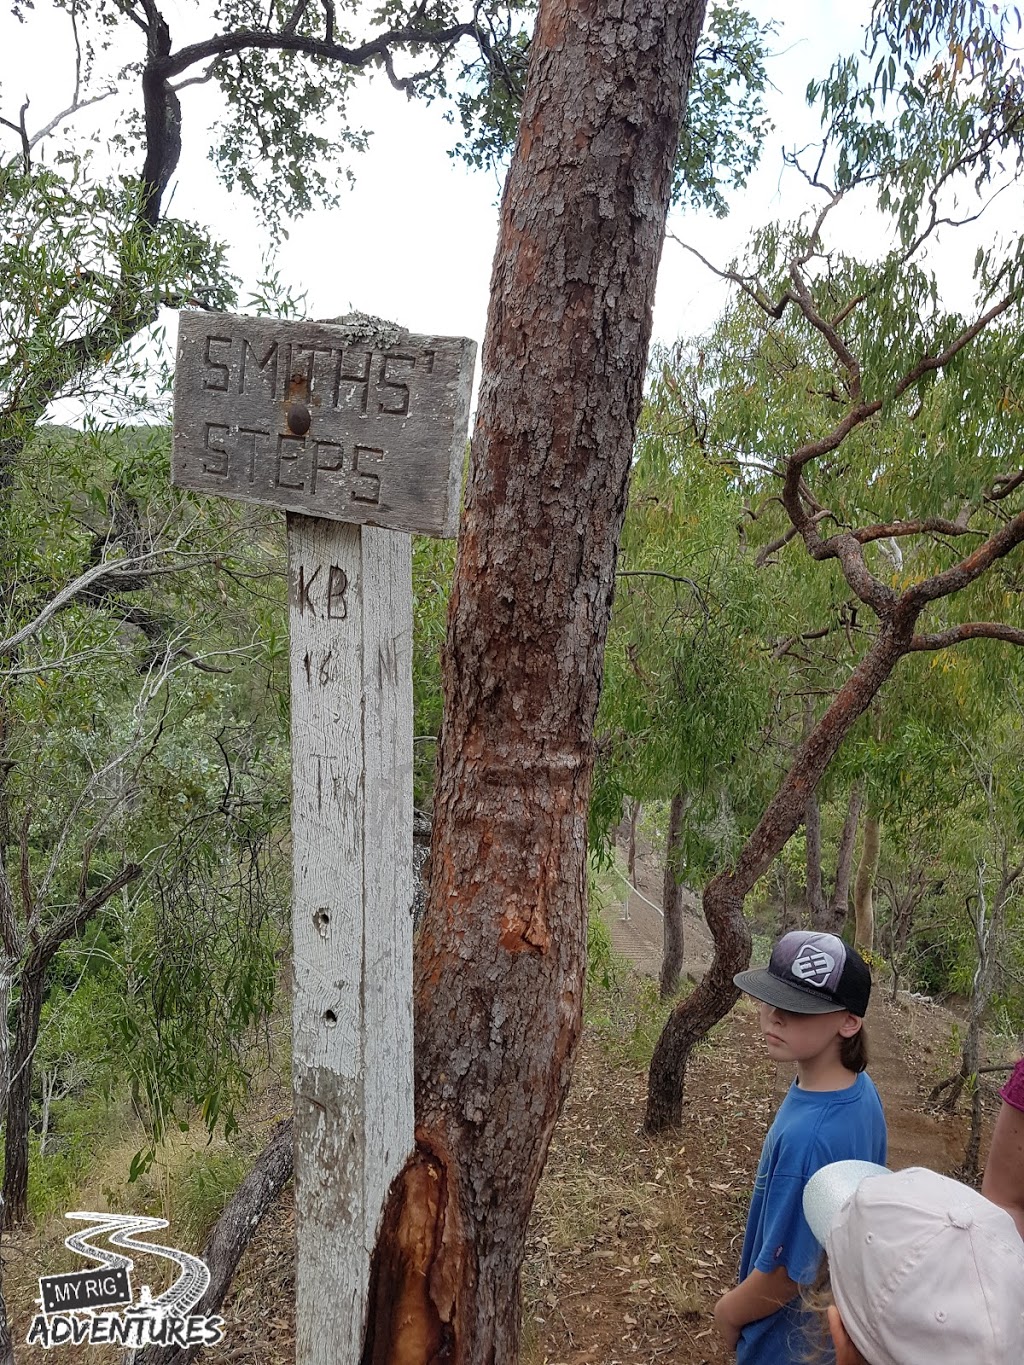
[0,0,1004,412]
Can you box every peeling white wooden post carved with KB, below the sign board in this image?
[288,513,412,1365]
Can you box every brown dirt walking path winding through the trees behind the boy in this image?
[606,853,967,1173]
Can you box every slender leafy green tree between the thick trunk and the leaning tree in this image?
[591,356,784,998]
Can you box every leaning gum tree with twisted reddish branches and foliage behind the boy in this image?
[646,0,1024,1129]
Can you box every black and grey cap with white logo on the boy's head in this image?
[733,930,871,1018]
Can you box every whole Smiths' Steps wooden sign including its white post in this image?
[172,314,475,1365]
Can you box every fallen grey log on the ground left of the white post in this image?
[128,1118,292,1365]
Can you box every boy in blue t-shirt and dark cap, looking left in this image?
[714,930,886,1365]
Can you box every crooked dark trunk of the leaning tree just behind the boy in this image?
[644,622,920,1133]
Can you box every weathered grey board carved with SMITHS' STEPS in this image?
[172,313,477,536]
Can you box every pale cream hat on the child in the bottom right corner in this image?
[804,1162,1024,1365]
